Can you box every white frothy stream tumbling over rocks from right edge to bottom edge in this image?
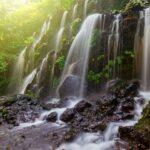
[57,93,150,150]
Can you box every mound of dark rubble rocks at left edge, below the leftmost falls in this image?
[0,95,42,126]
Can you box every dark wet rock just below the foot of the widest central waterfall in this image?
[74,100,92,112]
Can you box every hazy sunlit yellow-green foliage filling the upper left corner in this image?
[0,0,74,95]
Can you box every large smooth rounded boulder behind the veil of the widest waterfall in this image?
[59,75,81,98]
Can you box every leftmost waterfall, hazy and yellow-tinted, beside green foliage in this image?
[8,47,27,93]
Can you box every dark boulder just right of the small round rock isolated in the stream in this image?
[60,109,75,122]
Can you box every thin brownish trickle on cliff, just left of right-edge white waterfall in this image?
[134,11,144,78]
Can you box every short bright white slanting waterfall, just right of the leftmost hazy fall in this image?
[19,69,36,94]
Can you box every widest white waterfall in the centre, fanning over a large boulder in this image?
[59,14,102,96]
